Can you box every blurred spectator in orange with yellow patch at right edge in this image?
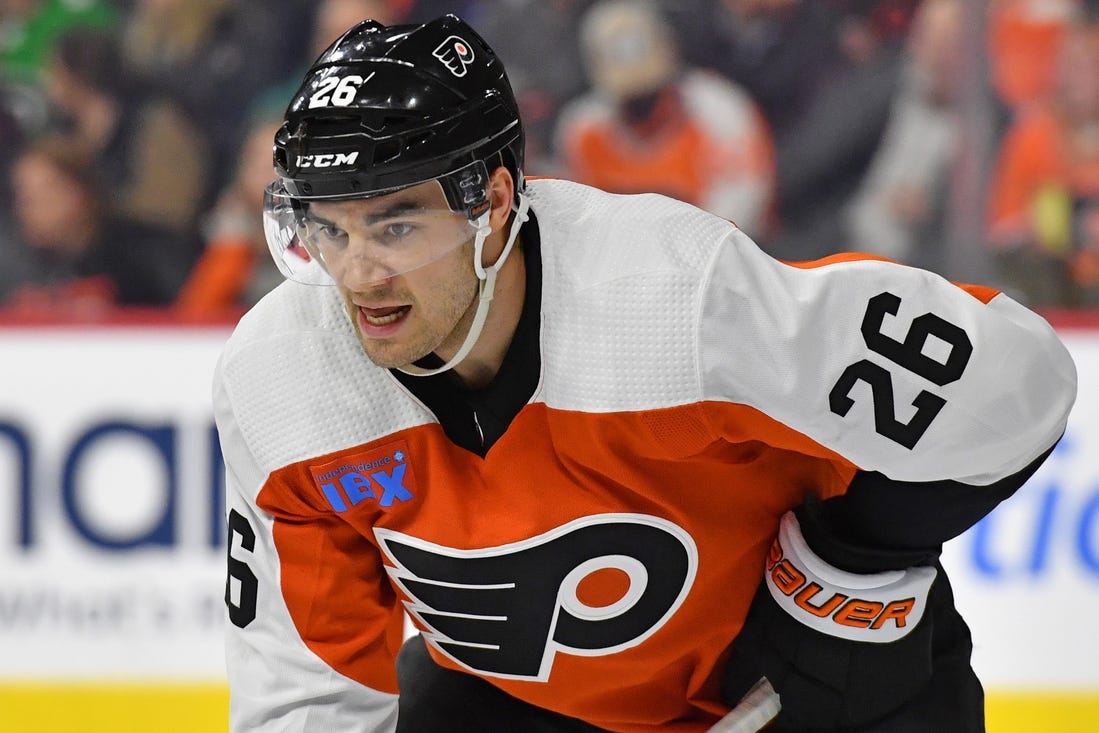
[989,15,1099,307]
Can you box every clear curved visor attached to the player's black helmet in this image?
[264,181,477,289]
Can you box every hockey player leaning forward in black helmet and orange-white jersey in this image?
[214,16,1076,733]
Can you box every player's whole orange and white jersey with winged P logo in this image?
[214,180,1076,733]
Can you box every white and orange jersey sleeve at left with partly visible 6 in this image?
[214,357,402,733]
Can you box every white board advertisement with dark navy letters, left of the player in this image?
[0,327,227,681]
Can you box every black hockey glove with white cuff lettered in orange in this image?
[722,502,937,731]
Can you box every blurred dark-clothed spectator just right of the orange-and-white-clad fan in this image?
[667,0,919,259]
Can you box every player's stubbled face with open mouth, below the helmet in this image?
[310,182,477,368]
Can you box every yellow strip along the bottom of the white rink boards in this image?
[0,682,1099,733]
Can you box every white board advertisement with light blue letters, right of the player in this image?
[943,330,1099,690]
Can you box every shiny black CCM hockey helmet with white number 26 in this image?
[268,15,523,216]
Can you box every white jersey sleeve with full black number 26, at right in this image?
[698,232,1076,486]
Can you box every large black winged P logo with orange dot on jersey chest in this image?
[374,514,698,681]
